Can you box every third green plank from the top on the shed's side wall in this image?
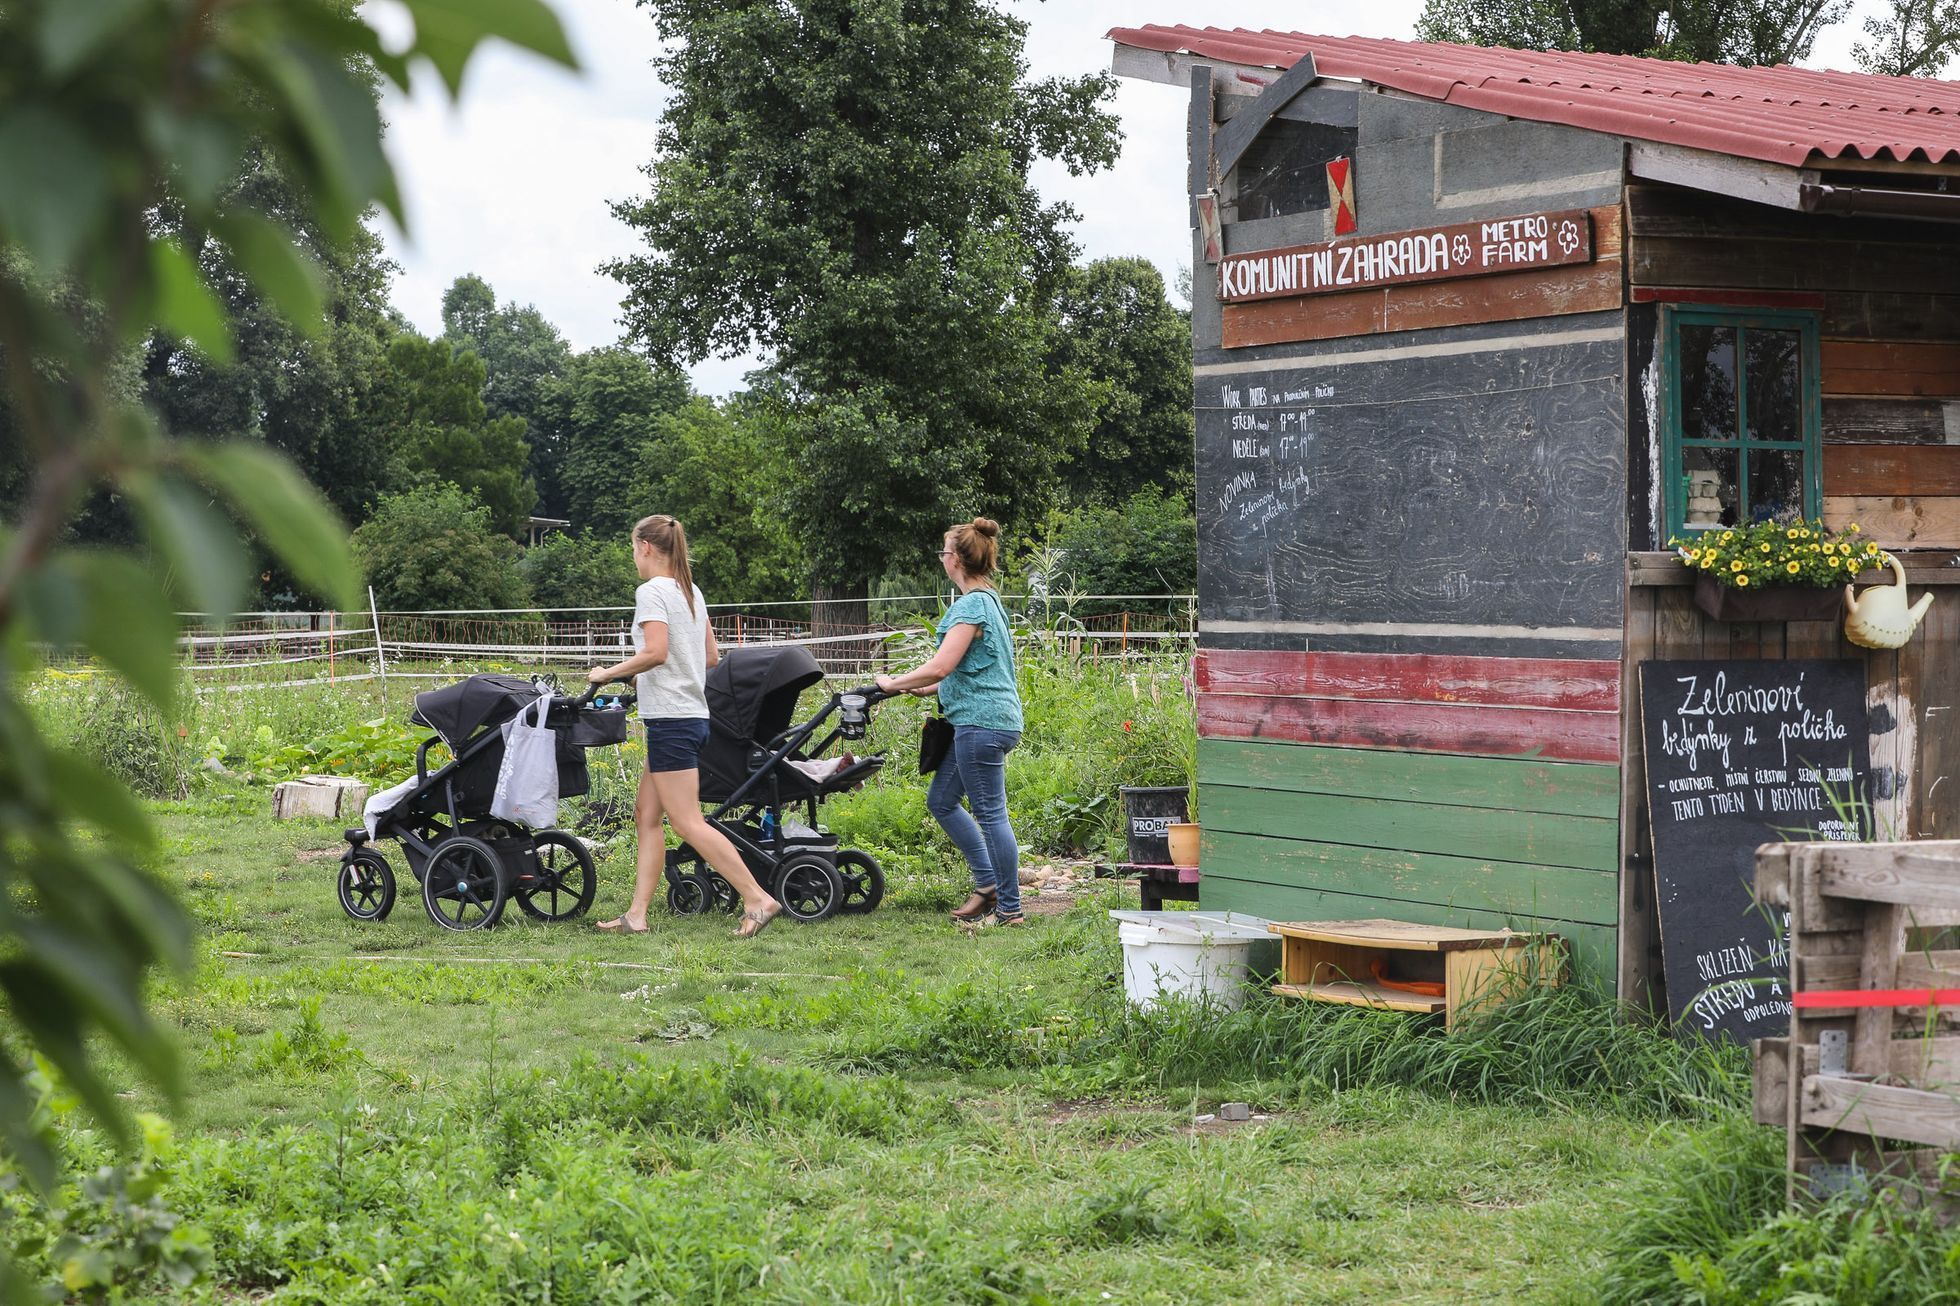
[1200,828,1619,926]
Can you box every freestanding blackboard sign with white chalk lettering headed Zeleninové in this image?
[1641,659,1872,1043]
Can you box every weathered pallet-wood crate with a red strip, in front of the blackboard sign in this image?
[1754,839,1960,1202]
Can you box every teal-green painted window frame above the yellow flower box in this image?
[1660,304,1823,539]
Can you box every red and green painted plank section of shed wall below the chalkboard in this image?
[1198,649,1621,984]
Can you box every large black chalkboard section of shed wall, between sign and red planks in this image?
[1198,316,1627,655]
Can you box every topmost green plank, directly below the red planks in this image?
[1198,739,1619,820]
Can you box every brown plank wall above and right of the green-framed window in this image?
[1627,184,1960,549]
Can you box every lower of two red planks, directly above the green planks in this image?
[1198,692,1619,763]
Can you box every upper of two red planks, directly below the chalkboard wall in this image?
[1198,649,1619,712]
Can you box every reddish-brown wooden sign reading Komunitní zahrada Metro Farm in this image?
[1219,208,1592,304]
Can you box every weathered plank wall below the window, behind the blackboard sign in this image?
[1621,553,1960,992]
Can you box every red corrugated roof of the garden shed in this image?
[1109,25,1960,167]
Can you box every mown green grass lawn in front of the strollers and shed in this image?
[3,790,1748,1302]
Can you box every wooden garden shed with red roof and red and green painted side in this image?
[1111,27,1960,1000]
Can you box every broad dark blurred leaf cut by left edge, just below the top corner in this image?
[0,104,110,271]
